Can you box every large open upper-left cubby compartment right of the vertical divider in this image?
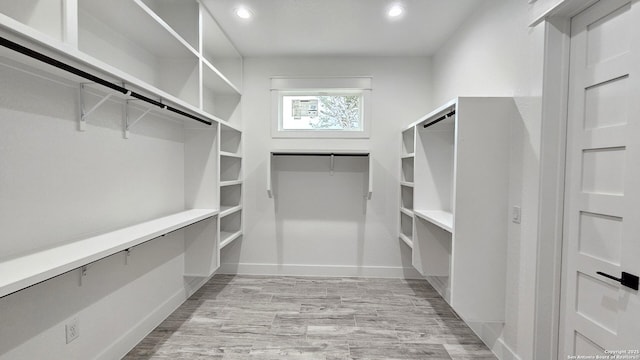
[78,0,200,107]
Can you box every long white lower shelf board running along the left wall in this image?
[0,209,218,297]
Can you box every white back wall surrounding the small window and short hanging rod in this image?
[221,57,431,277]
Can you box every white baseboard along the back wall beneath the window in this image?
[217,263,424,279]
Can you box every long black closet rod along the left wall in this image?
[0,37,212,125]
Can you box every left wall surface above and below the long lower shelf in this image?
[0,65,186,360]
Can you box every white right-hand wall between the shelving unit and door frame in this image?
[432,0,544,360]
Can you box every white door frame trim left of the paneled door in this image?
[531,0,597,360]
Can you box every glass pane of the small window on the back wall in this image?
[281,94,362,131]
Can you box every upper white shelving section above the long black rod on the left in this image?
[0,0,242,123]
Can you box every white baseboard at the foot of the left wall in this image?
[95,289,186,360]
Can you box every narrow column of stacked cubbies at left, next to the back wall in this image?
[219,125,243,248]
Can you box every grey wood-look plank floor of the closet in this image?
[125,275,496,360]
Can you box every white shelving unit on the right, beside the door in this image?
[400,97,518,344]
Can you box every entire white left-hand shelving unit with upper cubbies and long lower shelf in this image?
[0,0,242,290]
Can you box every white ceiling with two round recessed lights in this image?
[203,0,482,56]
